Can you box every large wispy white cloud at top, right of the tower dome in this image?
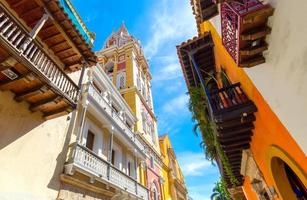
[144,0,196,59]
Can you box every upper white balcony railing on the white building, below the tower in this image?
[87,84,145,152]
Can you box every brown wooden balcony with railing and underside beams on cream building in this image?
[0,6,79,119]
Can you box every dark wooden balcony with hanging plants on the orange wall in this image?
[206,83,257,186]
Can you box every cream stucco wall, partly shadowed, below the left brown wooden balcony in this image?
[0,91,70,200]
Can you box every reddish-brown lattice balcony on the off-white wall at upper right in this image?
[221,0,274,67]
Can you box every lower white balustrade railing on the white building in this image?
[68,143,149,200]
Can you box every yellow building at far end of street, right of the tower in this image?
[159,134,188,200]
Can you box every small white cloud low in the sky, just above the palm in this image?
[177,151,214,176]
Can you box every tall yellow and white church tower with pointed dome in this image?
[96,24,166,200]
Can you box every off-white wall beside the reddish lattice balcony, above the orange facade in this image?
[211,0,307,154]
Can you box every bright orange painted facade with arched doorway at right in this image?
[200,21,307,199]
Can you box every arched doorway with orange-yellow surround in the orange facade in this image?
[270,147,307,200]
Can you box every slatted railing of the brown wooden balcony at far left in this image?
[0,6,79,104]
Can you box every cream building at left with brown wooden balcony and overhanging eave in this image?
[0,0,96,200]
